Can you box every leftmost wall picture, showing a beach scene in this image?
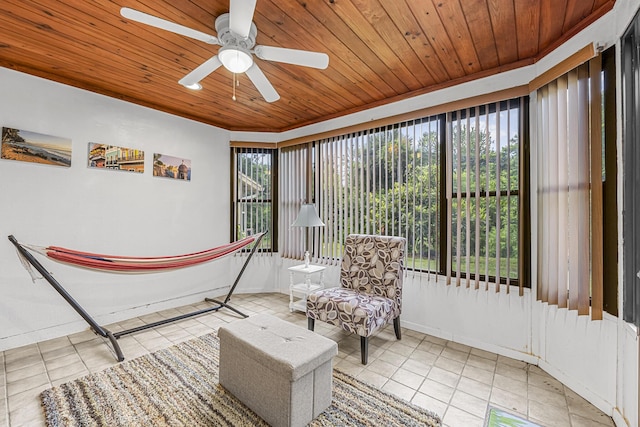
[1,127,71,167]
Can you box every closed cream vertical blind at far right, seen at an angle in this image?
[537,56,602,319]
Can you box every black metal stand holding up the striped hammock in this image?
[8,232,267,362]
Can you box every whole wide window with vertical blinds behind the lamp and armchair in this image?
[280,98,527,287]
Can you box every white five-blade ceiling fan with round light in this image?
[120,0,329,102]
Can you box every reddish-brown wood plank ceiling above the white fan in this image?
[0,0,615,132]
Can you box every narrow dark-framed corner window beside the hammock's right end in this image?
[231,148,277,252]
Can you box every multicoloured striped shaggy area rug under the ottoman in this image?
[41,334,441,427]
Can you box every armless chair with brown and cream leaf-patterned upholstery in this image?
[307,234,406,365]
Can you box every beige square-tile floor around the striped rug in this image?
[0,294,614,427]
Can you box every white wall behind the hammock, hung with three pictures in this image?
[0,68,252,350]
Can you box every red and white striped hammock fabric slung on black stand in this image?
[18,233,264,273]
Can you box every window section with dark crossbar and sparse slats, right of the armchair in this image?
[447,99,524,288]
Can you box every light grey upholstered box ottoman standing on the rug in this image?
[218,314,338,427]
